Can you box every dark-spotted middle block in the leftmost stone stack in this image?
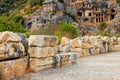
[0,43,26,61]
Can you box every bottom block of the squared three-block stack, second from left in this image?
[30,57,54,72]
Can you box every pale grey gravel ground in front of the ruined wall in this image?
[19,52,120,80]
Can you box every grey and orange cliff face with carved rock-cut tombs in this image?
[21,0,120,33]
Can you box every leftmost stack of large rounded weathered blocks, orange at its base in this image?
[0,32,28,80]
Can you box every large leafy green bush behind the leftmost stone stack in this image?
[0,15,27,33]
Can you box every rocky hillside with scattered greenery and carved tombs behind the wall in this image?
[0,0,120,35]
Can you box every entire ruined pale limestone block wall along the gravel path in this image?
[0,32,120,80]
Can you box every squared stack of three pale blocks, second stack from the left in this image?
[28,35,58,71]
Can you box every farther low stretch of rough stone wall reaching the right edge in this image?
[58,36,120,57]
